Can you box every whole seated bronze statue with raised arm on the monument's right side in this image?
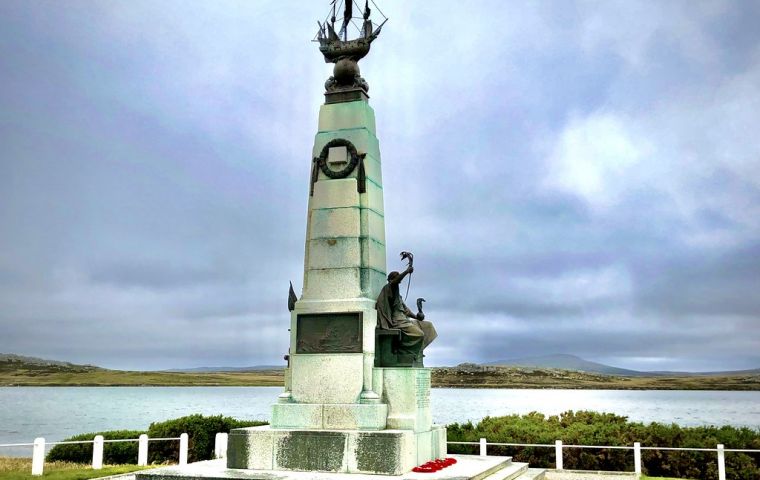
[375,252,438,365]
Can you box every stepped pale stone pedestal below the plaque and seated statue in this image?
[235,368,446,475]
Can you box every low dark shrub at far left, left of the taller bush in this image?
[47,430,146,465]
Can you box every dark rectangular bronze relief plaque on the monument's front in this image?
[296,312,362,353]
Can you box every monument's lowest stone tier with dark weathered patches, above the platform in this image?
[227,425,446,475]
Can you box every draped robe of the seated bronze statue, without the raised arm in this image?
[375,283,438,355]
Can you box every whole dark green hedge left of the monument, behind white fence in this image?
[47,415,266,465]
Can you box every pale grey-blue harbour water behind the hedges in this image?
[0,387,760,456]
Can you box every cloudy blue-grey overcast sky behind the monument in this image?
[0,0,760,370]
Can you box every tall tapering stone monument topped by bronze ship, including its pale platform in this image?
[137,0,544,480]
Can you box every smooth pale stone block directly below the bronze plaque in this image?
[290,351,364,403]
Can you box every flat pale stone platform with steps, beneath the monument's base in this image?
[136,455,544,480]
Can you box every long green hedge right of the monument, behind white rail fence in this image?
[448,411,760,480]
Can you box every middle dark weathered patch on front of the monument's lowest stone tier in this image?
[277,431,346,472]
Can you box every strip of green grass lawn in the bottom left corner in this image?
[0,457,151,480]
